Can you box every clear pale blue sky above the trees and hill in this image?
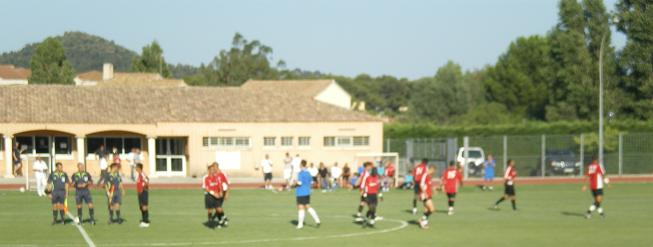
[0,0,625,78]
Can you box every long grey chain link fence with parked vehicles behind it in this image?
[384,133,653,177]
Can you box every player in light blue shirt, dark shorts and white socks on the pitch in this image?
[294,160,320,229]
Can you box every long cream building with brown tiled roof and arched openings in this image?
[0,72,383,177]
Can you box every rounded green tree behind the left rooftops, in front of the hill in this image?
[28,37,75,84]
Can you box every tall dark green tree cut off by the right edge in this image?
[616,0,653,119]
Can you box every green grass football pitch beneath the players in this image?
[0,184,653,247]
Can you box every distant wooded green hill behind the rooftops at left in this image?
[0,32,136,72]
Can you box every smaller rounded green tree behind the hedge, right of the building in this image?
[410,61,469,123]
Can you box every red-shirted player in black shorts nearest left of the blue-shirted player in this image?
[202,162,222,228]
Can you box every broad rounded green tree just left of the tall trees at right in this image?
[483,35,553,120]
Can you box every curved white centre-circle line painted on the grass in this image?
[100,216,408,246]
